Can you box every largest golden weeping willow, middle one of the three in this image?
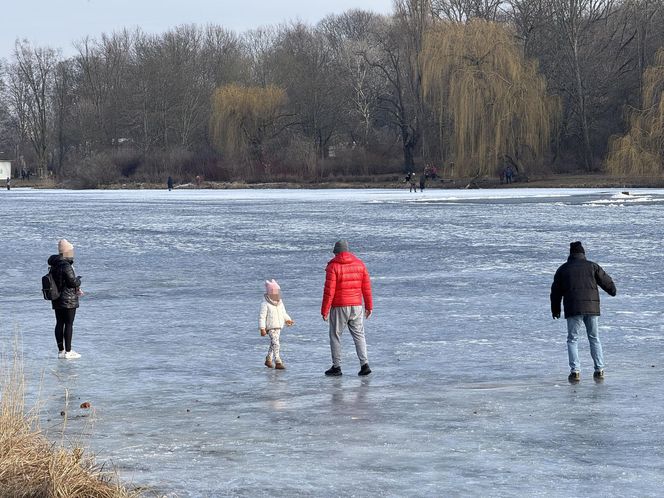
[422,19,560,176]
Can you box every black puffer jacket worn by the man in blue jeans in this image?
[551,253,616,318]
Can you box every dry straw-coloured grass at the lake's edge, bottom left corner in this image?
[0,347,147,498]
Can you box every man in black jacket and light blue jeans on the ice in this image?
[551,241,616,382]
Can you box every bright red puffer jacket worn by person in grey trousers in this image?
[320,252,373,316]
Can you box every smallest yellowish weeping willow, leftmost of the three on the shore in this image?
[210,83,286,167]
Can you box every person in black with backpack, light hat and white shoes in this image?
[48,239,83,359]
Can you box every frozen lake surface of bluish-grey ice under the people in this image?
[0,189,664,497]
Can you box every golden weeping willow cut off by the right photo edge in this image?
[606,49,664,176]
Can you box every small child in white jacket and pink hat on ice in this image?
[258,279,295,370]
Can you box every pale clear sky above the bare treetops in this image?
[0,0,392,58]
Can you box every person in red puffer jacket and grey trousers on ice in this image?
[320,240,373,377]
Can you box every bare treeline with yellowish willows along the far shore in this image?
[0,0,664,186]
